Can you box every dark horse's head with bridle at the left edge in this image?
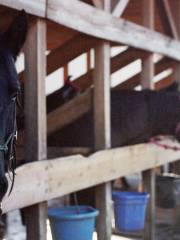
[0,11,27,202]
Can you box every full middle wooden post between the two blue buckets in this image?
[94,0,111,240]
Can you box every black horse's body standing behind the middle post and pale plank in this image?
[49,83,180,149]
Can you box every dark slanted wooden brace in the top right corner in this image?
[155,0,179,40]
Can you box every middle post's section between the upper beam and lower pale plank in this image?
[94,42,111,149]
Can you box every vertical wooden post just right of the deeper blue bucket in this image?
[141,0,156,240]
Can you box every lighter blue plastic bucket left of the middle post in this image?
[48,206,99,240]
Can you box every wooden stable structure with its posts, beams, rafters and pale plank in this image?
[0,0,180,240]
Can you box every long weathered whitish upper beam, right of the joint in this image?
[47,0,180,60]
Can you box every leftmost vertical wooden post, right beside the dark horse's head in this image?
[25,19,47,240]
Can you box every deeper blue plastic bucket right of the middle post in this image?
[113,192,149,231]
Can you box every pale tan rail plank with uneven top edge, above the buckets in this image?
[3,140,180,212]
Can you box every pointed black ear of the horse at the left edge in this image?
[4,10,28,58]
